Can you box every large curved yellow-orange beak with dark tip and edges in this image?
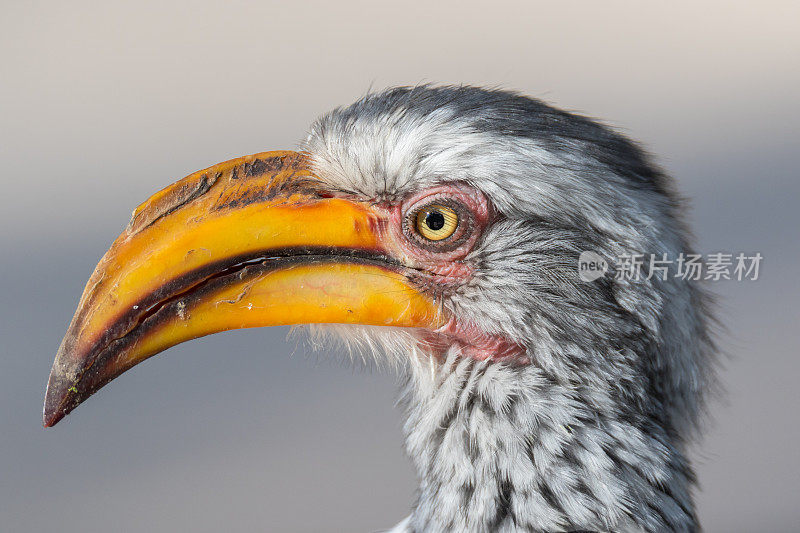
[44,152,444,427]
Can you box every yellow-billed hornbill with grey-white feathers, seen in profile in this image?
[44,86,714,532]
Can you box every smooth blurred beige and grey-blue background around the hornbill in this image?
[0,0,800,532]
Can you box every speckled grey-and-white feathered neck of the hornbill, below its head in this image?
[402,354,697,532]
